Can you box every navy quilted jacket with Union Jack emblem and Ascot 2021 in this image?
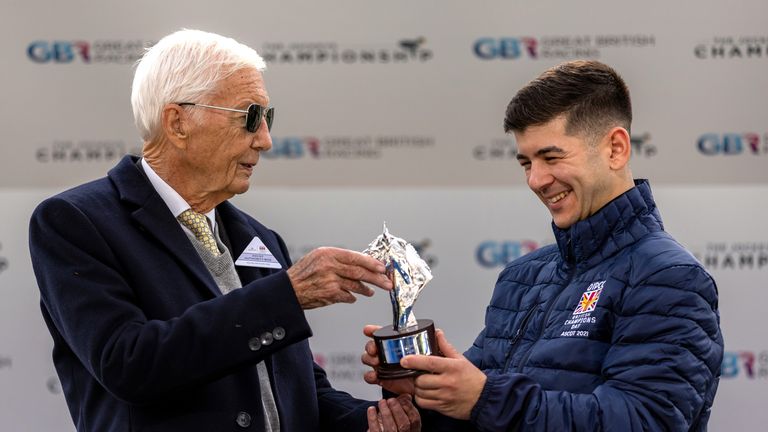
[465,180,723,432]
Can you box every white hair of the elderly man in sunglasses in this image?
[131,29,266,142]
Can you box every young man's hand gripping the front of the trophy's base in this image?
[400,330,486,420]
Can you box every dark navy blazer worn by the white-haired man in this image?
[30,156,371,432]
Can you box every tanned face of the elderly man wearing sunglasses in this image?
[183,69,272,201]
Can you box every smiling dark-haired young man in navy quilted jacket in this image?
[363,61,723,431]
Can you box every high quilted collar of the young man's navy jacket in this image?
[552,179,664,267]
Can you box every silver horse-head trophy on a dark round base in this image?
[363,224,442,380]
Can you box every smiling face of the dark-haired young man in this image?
[515,116,632,229]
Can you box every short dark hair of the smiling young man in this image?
[504,60,632,138]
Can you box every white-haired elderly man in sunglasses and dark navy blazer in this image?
[30,30,419,432]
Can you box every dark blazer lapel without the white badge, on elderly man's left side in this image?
[108,156,221,296]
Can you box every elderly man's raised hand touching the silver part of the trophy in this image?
[288,247,392,309]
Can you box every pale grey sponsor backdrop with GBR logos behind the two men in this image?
[0,0,768,431]
